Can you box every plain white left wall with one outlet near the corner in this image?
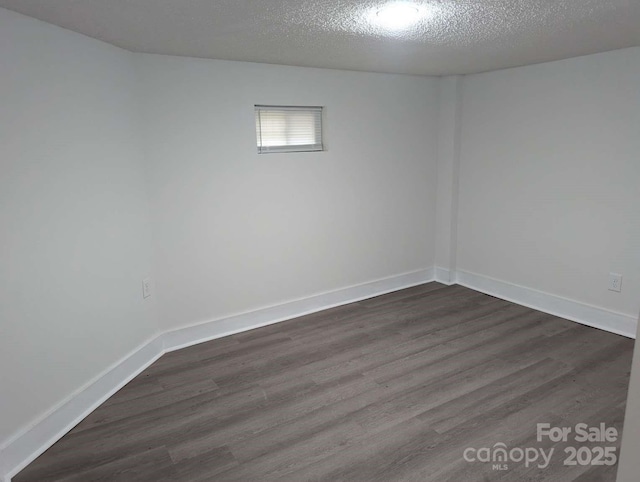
[0,9,156,446]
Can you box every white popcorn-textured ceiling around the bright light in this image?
[0,0,640,75]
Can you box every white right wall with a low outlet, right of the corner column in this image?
[457,48,640,319]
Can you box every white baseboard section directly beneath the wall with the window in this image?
[164,268,434,352]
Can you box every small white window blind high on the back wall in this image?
[256,105,323,154]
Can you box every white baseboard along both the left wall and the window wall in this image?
[0,268,434,482]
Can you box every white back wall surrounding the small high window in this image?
[139,55,438,329]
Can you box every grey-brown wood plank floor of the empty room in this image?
[14,283,633,482]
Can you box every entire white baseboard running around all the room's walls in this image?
[0,267,637,482]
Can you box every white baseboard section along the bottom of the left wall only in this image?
[0,337,163,482]
